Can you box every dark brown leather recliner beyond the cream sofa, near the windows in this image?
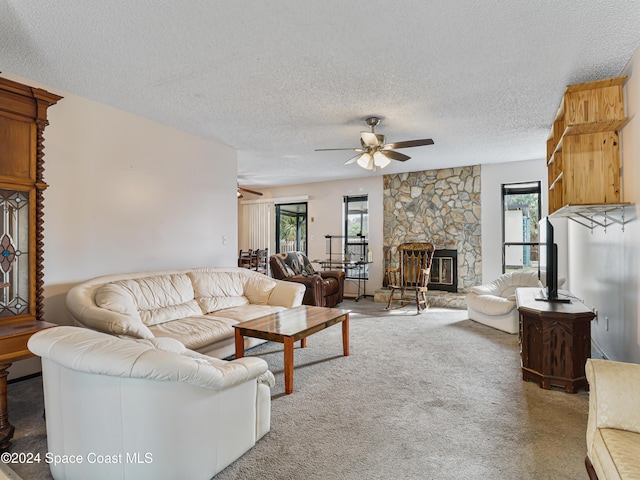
[269,252,345,307]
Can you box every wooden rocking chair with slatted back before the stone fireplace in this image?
[386,242,434,313]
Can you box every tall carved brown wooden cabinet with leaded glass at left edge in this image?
[0,78,62,450]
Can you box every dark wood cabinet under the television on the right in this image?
[516,288,595,393]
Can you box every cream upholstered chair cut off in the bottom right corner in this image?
[585,359,640,480]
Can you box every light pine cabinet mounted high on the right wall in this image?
[547,77,628,214]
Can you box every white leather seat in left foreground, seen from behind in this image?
[28,326,274,480]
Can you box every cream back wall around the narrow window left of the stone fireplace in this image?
[244,176,384,295]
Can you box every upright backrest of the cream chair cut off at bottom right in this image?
[585,358,640,453]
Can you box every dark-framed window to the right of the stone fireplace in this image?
[502,182,541,273]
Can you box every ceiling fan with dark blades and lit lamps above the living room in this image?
[316,117,433,171]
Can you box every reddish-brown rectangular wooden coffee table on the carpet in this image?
[233,305,351,395]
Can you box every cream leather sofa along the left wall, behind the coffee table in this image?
[66,267,305,358]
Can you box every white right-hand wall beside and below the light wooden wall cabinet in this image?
[569,49,640,363]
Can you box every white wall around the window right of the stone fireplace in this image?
[480,159,548,283]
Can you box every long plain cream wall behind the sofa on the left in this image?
[3,73,237,377]
